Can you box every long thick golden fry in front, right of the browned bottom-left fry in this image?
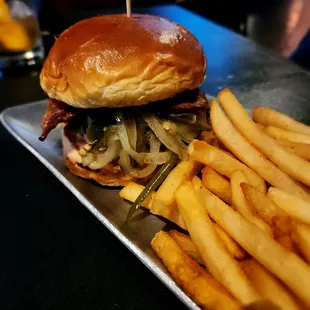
[176,182,260,304]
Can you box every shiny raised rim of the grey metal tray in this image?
[0,99,201,310]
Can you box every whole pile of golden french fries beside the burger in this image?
[120,89,310,310]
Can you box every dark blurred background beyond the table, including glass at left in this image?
[0,0,310,78]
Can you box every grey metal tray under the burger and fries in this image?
[0,100,200,310]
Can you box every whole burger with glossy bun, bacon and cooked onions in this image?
[39,15,208,186]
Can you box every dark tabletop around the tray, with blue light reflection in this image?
[0,5,310,310]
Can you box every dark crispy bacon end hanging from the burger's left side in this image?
[39,99,79,141]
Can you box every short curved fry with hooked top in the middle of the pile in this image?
[230,170,272,236]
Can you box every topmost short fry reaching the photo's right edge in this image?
[252,107,310,135]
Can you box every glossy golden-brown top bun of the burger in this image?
[40,15,206,108]
